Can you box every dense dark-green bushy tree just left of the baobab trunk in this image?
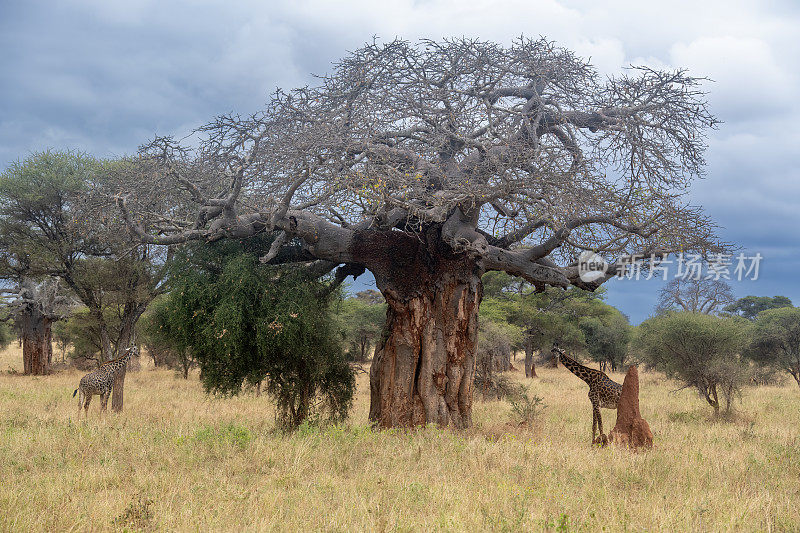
[163,235,355,428]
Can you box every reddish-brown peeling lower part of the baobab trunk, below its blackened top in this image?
[370,276,482,428]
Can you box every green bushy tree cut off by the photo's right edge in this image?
[747,306,800,386]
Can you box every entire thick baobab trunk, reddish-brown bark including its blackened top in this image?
[358,232,483,428]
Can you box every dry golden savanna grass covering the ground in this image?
[0,346,800,531]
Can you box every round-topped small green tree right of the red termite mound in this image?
[636,312,748,415]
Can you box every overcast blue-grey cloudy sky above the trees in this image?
[0,0,800,323]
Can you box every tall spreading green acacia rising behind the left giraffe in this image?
[0,151,164,411]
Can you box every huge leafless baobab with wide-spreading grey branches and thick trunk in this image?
[119,38,720,427]
